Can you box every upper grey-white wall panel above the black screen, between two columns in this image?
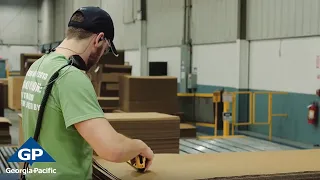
[147,0,184,47]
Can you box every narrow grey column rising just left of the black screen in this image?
[138,0,149,76]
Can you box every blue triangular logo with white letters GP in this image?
[8,137,55,165]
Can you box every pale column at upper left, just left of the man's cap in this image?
[38,0,55,44]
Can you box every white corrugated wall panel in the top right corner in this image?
[247,0,320,40]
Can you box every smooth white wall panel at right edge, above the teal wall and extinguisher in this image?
[249,37,320,94]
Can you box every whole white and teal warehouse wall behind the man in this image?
[0,0,320,144]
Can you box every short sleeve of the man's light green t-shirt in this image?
[56,70,104,128]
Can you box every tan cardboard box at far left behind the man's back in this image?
[8,76,24,110]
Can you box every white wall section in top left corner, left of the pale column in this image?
[0,0,39,71]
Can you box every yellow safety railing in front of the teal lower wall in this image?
[177,91,288,141]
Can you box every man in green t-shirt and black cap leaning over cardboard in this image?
[21,7,153,180]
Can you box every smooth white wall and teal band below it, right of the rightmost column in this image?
[249,37,320,144]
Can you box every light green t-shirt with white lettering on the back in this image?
[21,52,104,180]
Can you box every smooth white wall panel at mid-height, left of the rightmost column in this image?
[192,42,239,88]
